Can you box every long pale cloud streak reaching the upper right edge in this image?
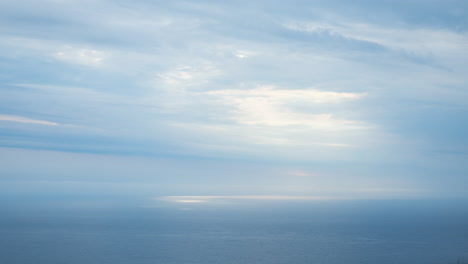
[282,20,468,65]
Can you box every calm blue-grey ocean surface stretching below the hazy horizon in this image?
[0,201,468,264]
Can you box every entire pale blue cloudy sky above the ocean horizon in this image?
[0,0,468,202]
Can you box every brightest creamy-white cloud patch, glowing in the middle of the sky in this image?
[207,86,365,129]
